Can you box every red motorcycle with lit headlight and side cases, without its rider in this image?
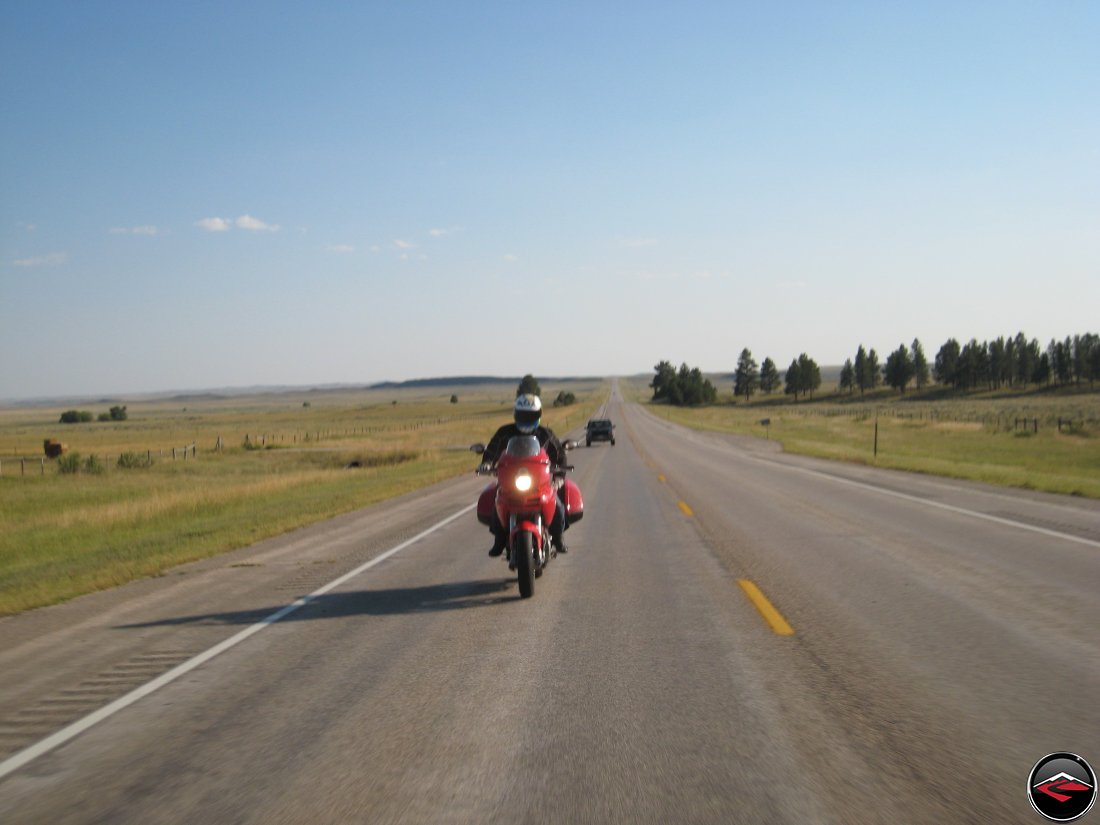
[473,436,584,598]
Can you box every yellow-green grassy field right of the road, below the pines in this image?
[623,377,1100,498]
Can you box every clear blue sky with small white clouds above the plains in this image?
[0,0,1100,399]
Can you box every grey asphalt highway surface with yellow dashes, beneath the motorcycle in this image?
[0,392,1100,825]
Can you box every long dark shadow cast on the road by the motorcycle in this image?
[116,579,520,630]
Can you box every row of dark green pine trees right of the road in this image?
[650,332,1100,405]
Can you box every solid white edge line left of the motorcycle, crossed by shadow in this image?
[0,503,477,780]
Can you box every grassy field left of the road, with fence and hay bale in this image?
[0,382,607,615]
